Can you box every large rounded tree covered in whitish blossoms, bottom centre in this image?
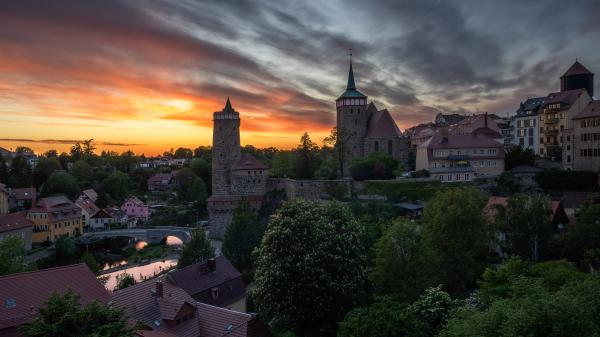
[253,200,366,336]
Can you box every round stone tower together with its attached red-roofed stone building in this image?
[207,98,269,238]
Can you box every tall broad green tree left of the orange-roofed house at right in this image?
[423,188,492,296]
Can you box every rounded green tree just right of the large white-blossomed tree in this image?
[370,222,438,302]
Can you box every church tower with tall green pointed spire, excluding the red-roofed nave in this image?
[335,59,369,177]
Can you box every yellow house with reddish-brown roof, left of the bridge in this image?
[27,196,83,243]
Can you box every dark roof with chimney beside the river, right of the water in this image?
[168,255,246,306]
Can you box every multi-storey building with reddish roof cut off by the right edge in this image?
[572,101,600,171]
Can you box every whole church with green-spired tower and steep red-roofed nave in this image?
[335,61,409,177]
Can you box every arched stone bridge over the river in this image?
[76,227,193,244]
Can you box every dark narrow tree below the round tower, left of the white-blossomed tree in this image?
[222,201,263,271]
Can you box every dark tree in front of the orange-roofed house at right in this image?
[496,194,553,262]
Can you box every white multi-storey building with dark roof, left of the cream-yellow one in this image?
[511,97,546,155]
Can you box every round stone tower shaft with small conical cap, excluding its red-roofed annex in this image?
[212,98,241,195]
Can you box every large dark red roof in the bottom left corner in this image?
[0,263,110,330]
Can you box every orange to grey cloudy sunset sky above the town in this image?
[0,0,600,155]
